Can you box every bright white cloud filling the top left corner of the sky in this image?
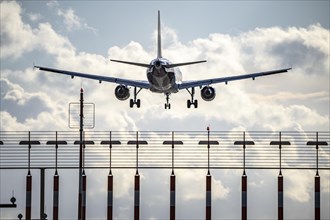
[0,1,75,60]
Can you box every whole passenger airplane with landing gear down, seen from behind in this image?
[34,11,291,109]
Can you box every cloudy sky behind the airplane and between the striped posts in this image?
[0,1,330,219]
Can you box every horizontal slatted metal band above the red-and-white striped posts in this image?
[0,131,330,170]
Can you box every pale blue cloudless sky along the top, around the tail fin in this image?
[3,1,330,68]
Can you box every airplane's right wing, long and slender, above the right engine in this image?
[178,68,291,89]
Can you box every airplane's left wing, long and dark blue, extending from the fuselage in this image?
[34,66,150,89]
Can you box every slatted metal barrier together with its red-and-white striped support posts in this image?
[0,129,330,220]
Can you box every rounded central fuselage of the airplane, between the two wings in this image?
[147,58,182,94]
